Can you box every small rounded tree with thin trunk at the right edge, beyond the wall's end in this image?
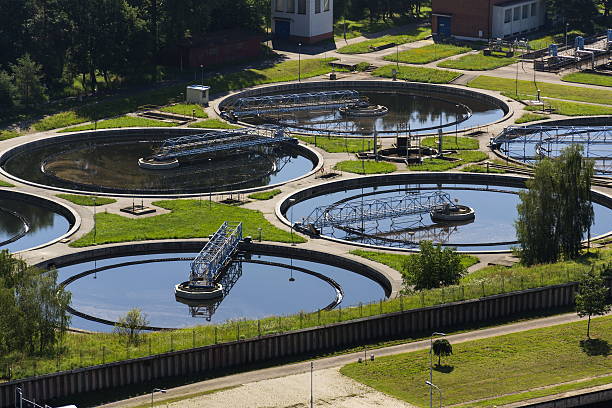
[576,268,610,338]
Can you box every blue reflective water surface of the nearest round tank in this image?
[59,253,385,331]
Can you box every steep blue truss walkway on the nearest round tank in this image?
[189,221,242,286]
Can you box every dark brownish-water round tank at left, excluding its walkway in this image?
[0,129,319,195]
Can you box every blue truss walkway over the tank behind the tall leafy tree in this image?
[295,191,455,233]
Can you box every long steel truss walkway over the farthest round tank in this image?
[228,90,363,117]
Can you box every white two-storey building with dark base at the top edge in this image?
[272,0,334,44]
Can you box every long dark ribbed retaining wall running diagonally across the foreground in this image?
[0,276,596,408]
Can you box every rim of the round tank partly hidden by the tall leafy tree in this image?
[274,172,612,254]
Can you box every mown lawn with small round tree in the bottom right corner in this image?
[340,317,612,406]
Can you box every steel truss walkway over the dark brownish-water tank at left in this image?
[153,126,295,161]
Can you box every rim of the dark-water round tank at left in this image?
[0,127,324,199]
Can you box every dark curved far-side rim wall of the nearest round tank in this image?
[34,240,394,330]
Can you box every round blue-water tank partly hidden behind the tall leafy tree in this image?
[277,173,612,252]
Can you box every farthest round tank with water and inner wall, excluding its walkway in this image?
[218,81,510,137]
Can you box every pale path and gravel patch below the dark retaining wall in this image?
[102,313,608,408]
